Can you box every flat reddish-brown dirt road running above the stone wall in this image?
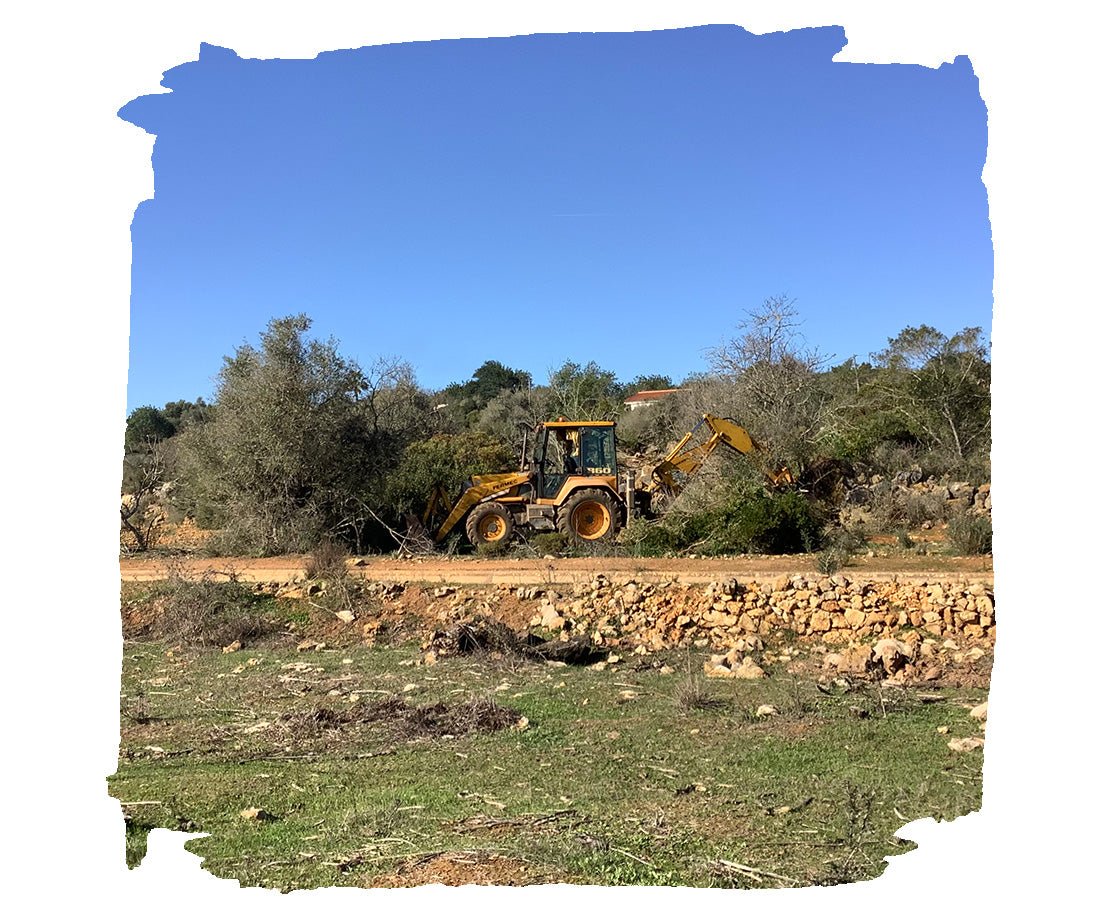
[121,556,992,585]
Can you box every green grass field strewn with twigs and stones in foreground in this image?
[109,623,987,890]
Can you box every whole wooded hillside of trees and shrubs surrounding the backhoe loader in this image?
[121,296,991,556]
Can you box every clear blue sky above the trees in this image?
[121,26,992,409]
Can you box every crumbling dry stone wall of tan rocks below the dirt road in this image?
[240,574,996,680]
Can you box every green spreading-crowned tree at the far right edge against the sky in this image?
[874,325,991,461]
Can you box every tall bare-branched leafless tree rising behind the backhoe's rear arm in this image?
[708,295,828,466]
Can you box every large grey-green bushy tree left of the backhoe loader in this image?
[177,314,387,554]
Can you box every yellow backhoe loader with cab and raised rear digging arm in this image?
[422,415,793,547]
